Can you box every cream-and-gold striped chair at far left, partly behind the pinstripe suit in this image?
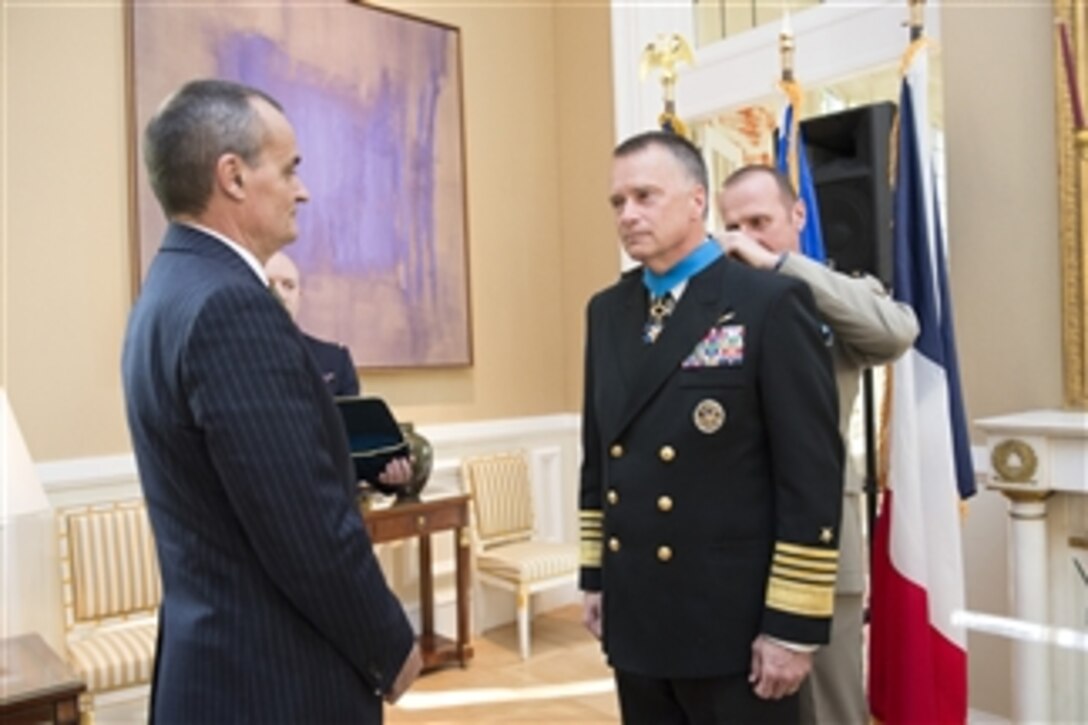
[57,499,162,713]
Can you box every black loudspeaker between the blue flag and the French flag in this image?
[801,101,895,286]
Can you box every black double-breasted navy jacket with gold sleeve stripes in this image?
[580,253,842,678]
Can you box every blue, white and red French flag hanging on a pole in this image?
[869,40,975,724]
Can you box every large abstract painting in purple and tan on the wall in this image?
[128,0,471,368]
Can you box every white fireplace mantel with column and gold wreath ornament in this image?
[976,410,1088,723]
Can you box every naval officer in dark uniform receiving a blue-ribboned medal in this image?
[580,132,842,723]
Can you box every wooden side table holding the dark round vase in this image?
[362,494,472,672]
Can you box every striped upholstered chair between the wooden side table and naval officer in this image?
[461,452,578,660]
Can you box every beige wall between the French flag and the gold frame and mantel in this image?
[941,0,1062,717]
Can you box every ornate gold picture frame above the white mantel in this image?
[1054,0,1088,409]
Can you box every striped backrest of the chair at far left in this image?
[57,499,162,630]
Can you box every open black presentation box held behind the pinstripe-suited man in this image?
[336,396,409,493]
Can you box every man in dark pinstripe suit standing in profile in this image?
[122,81,421,723]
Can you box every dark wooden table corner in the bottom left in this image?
[0,634,87,725]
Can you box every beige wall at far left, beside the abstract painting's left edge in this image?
[0,2,129,460]
